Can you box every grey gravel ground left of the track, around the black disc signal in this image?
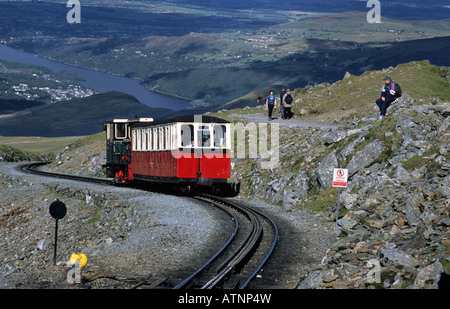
[0,163,236,288]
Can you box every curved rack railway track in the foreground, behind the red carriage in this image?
[175,194,278,289]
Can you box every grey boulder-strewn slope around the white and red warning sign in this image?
[230,94,450,288]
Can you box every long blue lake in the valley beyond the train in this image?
[0,44,190,110]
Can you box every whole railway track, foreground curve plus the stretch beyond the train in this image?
[20,162,279,289]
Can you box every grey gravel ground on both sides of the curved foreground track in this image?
[0,163,332,289]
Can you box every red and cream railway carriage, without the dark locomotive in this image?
[127,116,231,188]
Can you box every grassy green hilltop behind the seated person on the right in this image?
[293,61,450,120]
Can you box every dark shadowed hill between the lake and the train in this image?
[0,91,173,137]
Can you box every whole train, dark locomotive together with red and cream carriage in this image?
[104,115,239,194]
